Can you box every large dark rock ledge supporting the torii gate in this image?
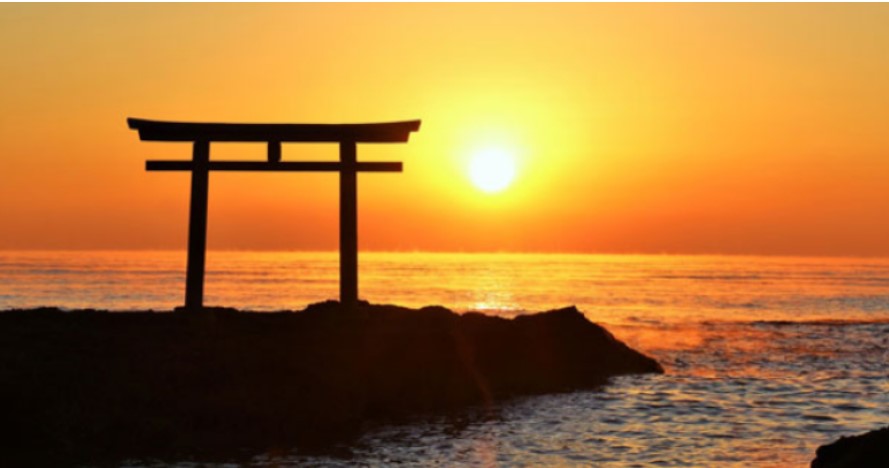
[0,302,663,466]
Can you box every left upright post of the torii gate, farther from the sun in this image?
[185,141,210,311]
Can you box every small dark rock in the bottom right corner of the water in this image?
[812,426,889,468]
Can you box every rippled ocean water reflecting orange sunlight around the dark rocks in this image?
[0,251,889,467]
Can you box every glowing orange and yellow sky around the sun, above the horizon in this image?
[0,4,889,256]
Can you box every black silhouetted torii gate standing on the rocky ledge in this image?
[127,118,420,310]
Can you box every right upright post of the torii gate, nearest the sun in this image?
[340,141,358,311]
